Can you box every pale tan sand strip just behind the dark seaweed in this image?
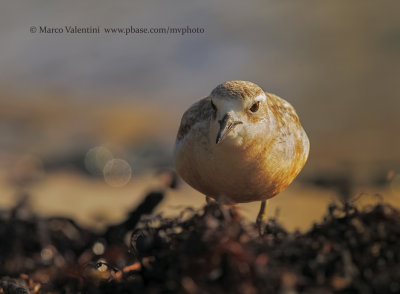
[0,172,400,230]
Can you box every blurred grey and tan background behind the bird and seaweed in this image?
[0,0,400,229]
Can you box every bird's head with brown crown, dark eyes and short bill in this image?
[210,81,267,145]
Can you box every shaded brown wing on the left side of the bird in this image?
[176,97,214,141]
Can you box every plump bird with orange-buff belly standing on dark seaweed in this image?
[174,80,310,234]
